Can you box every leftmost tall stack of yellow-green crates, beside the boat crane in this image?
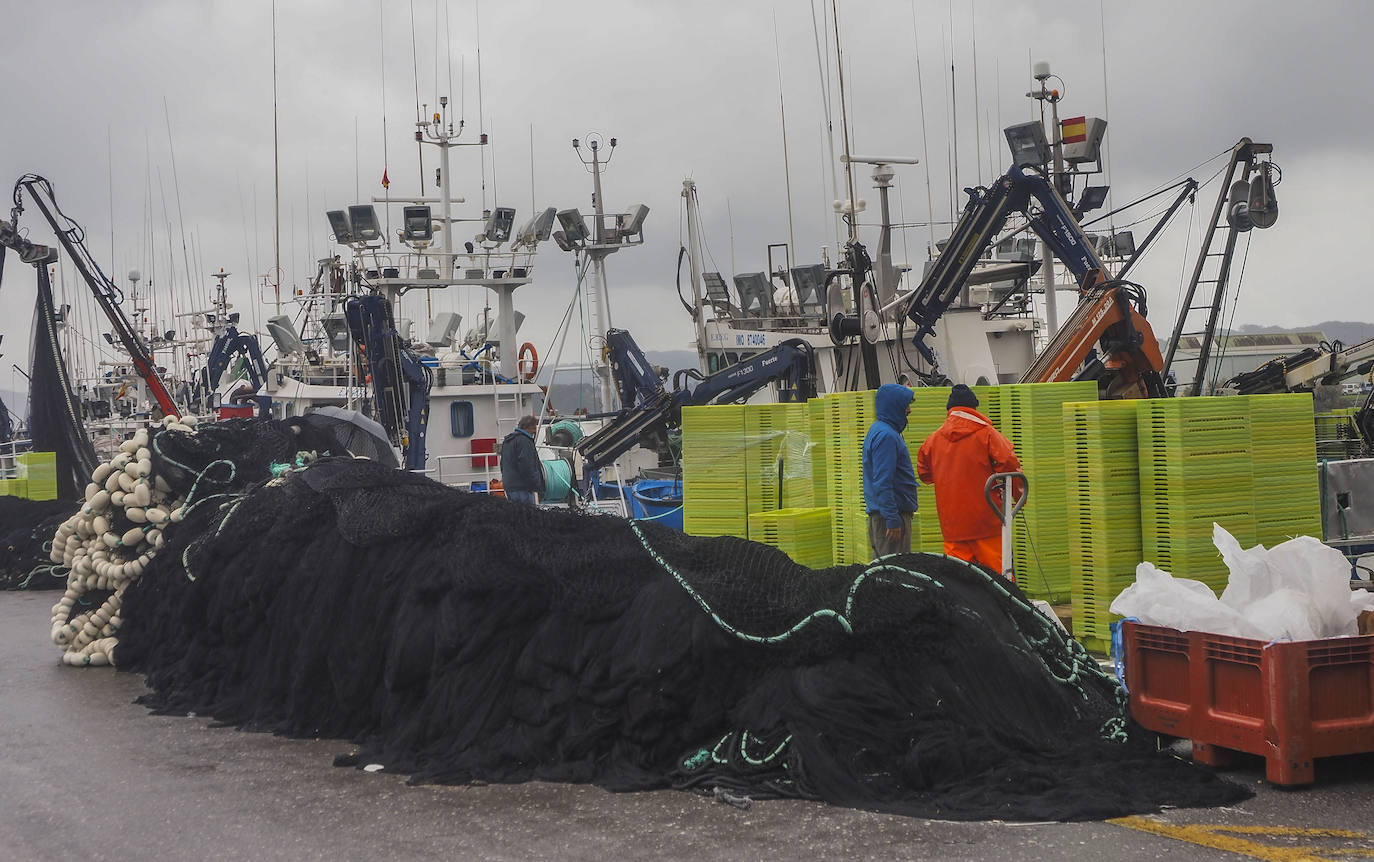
[683,404,749,539]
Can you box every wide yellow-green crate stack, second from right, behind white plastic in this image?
[1136,396,1257,593]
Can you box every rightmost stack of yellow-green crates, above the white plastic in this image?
[1249,393,1322,546]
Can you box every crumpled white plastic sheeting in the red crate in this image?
[1112,524,1374,641]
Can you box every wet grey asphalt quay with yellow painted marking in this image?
[0,593,1374,862]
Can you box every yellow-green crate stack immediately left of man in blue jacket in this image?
[820,392,879,565]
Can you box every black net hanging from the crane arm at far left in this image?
[29,267,96,502]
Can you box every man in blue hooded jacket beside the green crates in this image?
[863,384,918,557]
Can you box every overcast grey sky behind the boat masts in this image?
[0,0,1374,395]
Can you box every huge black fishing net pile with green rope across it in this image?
[115,423,1248,819]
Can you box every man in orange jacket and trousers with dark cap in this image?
[916,384,1021,573]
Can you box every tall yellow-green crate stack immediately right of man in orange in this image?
[999,381,1098,602]
